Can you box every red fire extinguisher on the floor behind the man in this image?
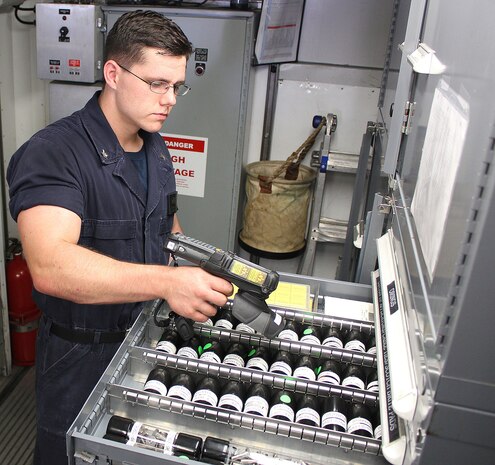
[6,239,41,366]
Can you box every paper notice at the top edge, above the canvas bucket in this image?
[255,0,304,64]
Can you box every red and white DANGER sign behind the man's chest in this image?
[160,133,208,197]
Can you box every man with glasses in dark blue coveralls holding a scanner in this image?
[7,11,232,465]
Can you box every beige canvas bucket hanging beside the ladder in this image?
[239,161,317,254]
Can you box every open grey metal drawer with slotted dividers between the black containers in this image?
[67,260,418,465]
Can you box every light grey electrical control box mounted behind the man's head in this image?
[36,3,104,82]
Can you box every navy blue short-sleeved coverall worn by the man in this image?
[7,92,176,465]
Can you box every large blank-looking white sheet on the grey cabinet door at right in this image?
[411,79,469,281]
